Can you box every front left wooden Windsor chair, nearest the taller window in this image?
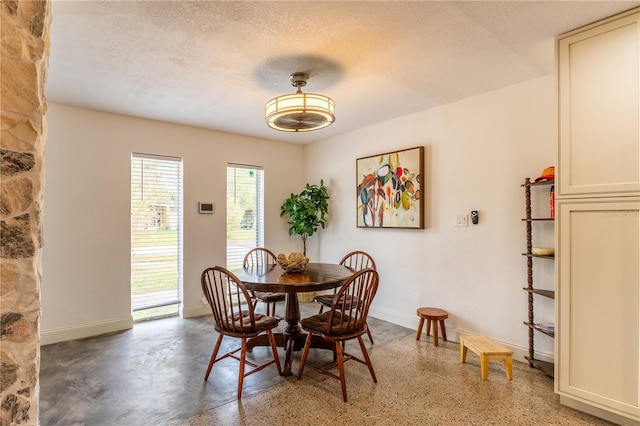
[201,266,282,399]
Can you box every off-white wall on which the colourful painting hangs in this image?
[305,76,557,359]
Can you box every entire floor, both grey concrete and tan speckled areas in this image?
[40,303,610,426]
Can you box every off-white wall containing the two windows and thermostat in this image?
[41,104,304,344]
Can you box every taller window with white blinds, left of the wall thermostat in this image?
[131,154,182,319]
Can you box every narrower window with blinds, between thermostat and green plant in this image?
[227,164,264,269]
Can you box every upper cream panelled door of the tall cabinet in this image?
[556,9,640,197]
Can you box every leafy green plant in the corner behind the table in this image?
[280,179,329,256]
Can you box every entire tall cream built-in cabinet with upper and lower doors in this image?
[555,9,640,425]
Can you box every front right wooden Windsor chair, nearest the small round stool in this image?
[298,268,378,402]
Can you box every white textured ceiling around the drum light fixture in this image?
[46,0,640,144]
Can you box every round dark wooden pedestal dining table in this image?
[231,263,355,376]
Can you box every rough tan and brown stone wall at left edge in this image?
[0,0,51,426]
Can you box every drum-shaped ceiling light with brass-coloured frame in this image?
[264,72,336,132]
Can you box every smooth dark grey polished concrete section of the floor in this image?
[40,303,413,426]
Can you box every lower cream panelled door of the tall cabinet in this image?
[555,198,640,419]
